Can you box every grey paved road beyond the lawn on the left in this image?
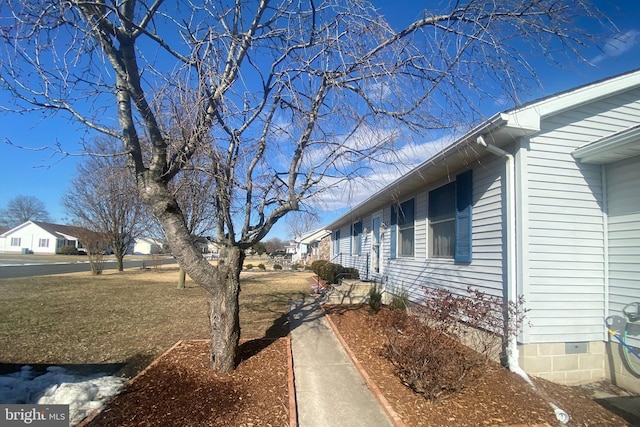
[0,257,176,279]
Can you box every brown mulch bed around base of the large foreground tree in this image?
[87,339,289,427]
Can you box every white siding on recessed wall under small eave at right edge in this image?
[606,157,640,345]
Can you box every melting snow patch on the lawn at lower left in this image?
[0,365,126,425]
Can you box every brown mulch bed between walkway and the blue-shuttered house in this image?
[325,306,628,427]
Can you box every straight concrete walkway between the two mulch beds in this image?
[289,299,393,427]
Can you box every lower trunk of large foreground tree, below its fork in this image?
[208,248,244,372]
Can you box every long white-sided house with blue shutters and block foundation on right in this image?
[327,70,640,392]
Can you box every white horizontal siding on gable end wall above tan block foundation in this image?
[524,90,640,342]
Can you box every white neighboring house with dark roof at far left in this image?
[0,221,86,254]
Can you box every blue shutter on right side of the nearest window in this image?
[455,170,473,262]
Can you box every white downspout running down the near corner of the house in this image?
[476,135,569,424]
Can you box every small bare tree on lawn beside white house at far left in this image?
[62,138,145,271]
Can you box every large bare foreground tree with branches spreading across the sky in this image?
[0,0,608,371]
